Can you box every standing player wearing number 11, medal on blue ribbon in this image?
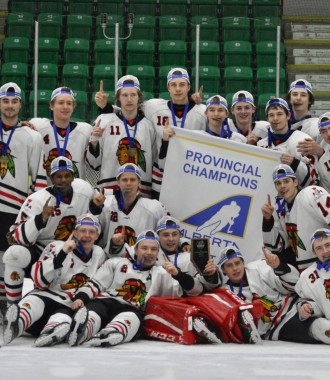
[86,75,157,198]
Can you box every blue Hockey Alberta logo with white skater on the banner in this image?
[182,195,252,237]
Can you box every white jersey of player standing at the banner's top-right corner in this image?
[257,131,317,187]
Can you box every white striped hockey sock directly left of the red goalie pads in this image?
[105,311,141,343]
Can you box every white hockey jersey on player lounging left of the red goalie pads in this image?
[74,257,201,310]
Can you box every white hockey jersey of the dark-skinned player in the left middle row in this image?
[10,178,94,253]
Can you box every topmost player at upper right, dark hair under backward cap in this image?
[285,79,319,141]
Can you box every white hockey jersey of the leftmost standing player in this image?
[0,126,47,214]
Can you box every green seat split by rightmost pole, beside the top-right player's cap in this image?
[256,67,287,94]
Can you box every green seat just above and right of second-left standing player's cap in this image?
[62,63,89,91]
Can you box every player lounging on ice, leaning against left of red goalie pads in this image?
[68,230,203,347]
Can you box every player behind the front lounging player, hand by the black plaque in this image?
[156,216,222,290]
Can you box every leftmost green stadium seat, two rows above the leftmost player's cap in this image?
[2,37,30,63]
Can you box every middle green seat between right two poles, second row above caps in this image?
[223,41,252,66]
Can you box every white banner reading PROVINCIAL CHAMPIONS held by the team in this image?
[160,128,281,263]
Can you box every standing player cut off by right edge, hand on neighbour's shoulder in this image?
[298,112,330,192]
